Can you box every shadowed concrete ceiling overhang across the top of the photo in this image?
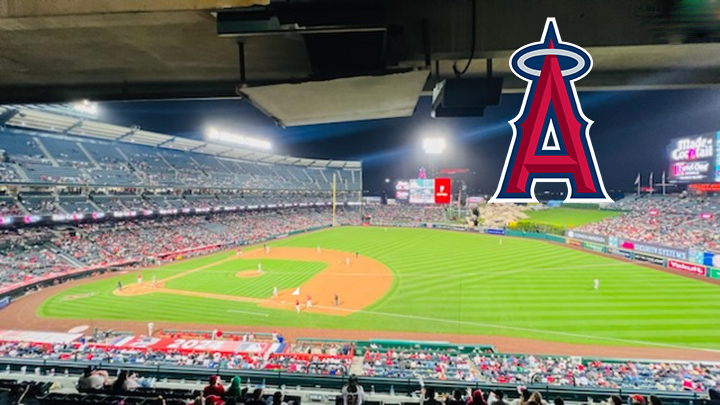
[0,0,720,103]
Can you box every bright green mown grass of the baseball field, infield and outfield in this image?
[37,227,720,349]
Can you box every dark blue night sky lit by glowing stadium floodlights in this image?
[99,90,720,195]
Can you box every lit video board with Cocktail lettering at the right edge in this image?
[667,131,720,183]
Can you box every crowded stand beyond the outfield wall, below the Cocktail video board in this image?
[577,195,720,253]
